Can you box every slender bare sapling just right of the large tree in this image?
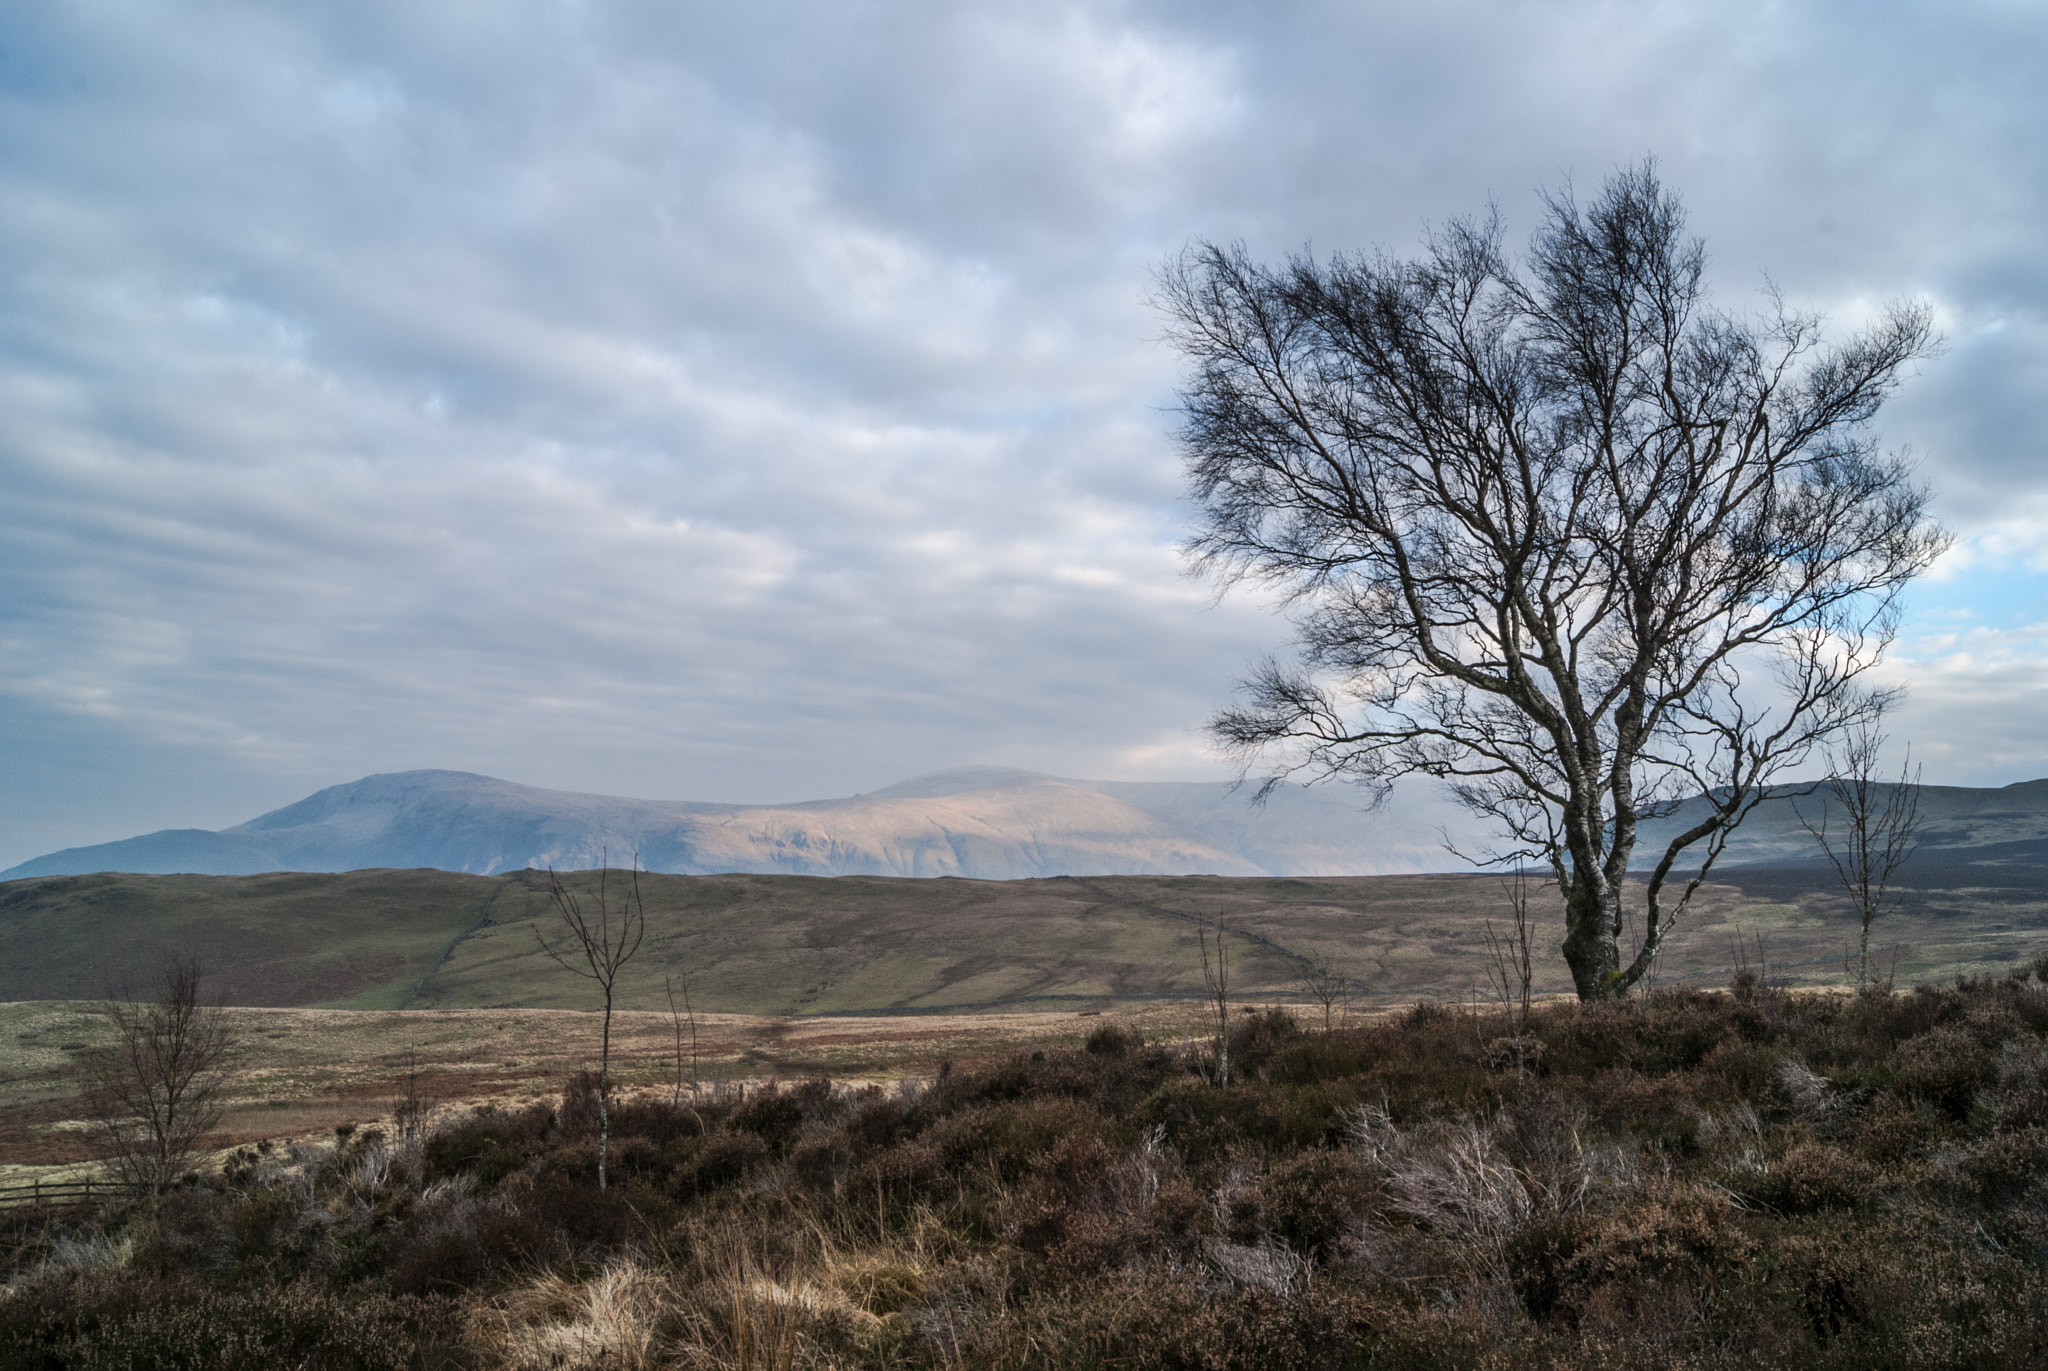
[1792,725,1921,990]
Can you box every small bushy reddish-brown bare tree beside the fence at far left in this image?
[86,955,236,1195]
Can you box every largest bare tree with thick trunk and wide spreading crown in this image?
[1161,162,1948,998]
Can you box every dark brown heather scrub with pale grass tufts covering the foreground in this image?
[12,967,2048,1369]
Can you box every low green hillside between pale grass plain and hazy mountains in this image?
[12,863,2048,1014]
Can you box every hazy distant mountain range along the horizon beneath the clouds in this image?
[12,766,2048,879]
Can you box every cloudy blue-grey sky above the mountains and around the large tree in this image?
[0,0,2048,867]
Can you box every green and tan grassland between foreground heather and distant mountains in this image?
[0,865,2048,1170]
